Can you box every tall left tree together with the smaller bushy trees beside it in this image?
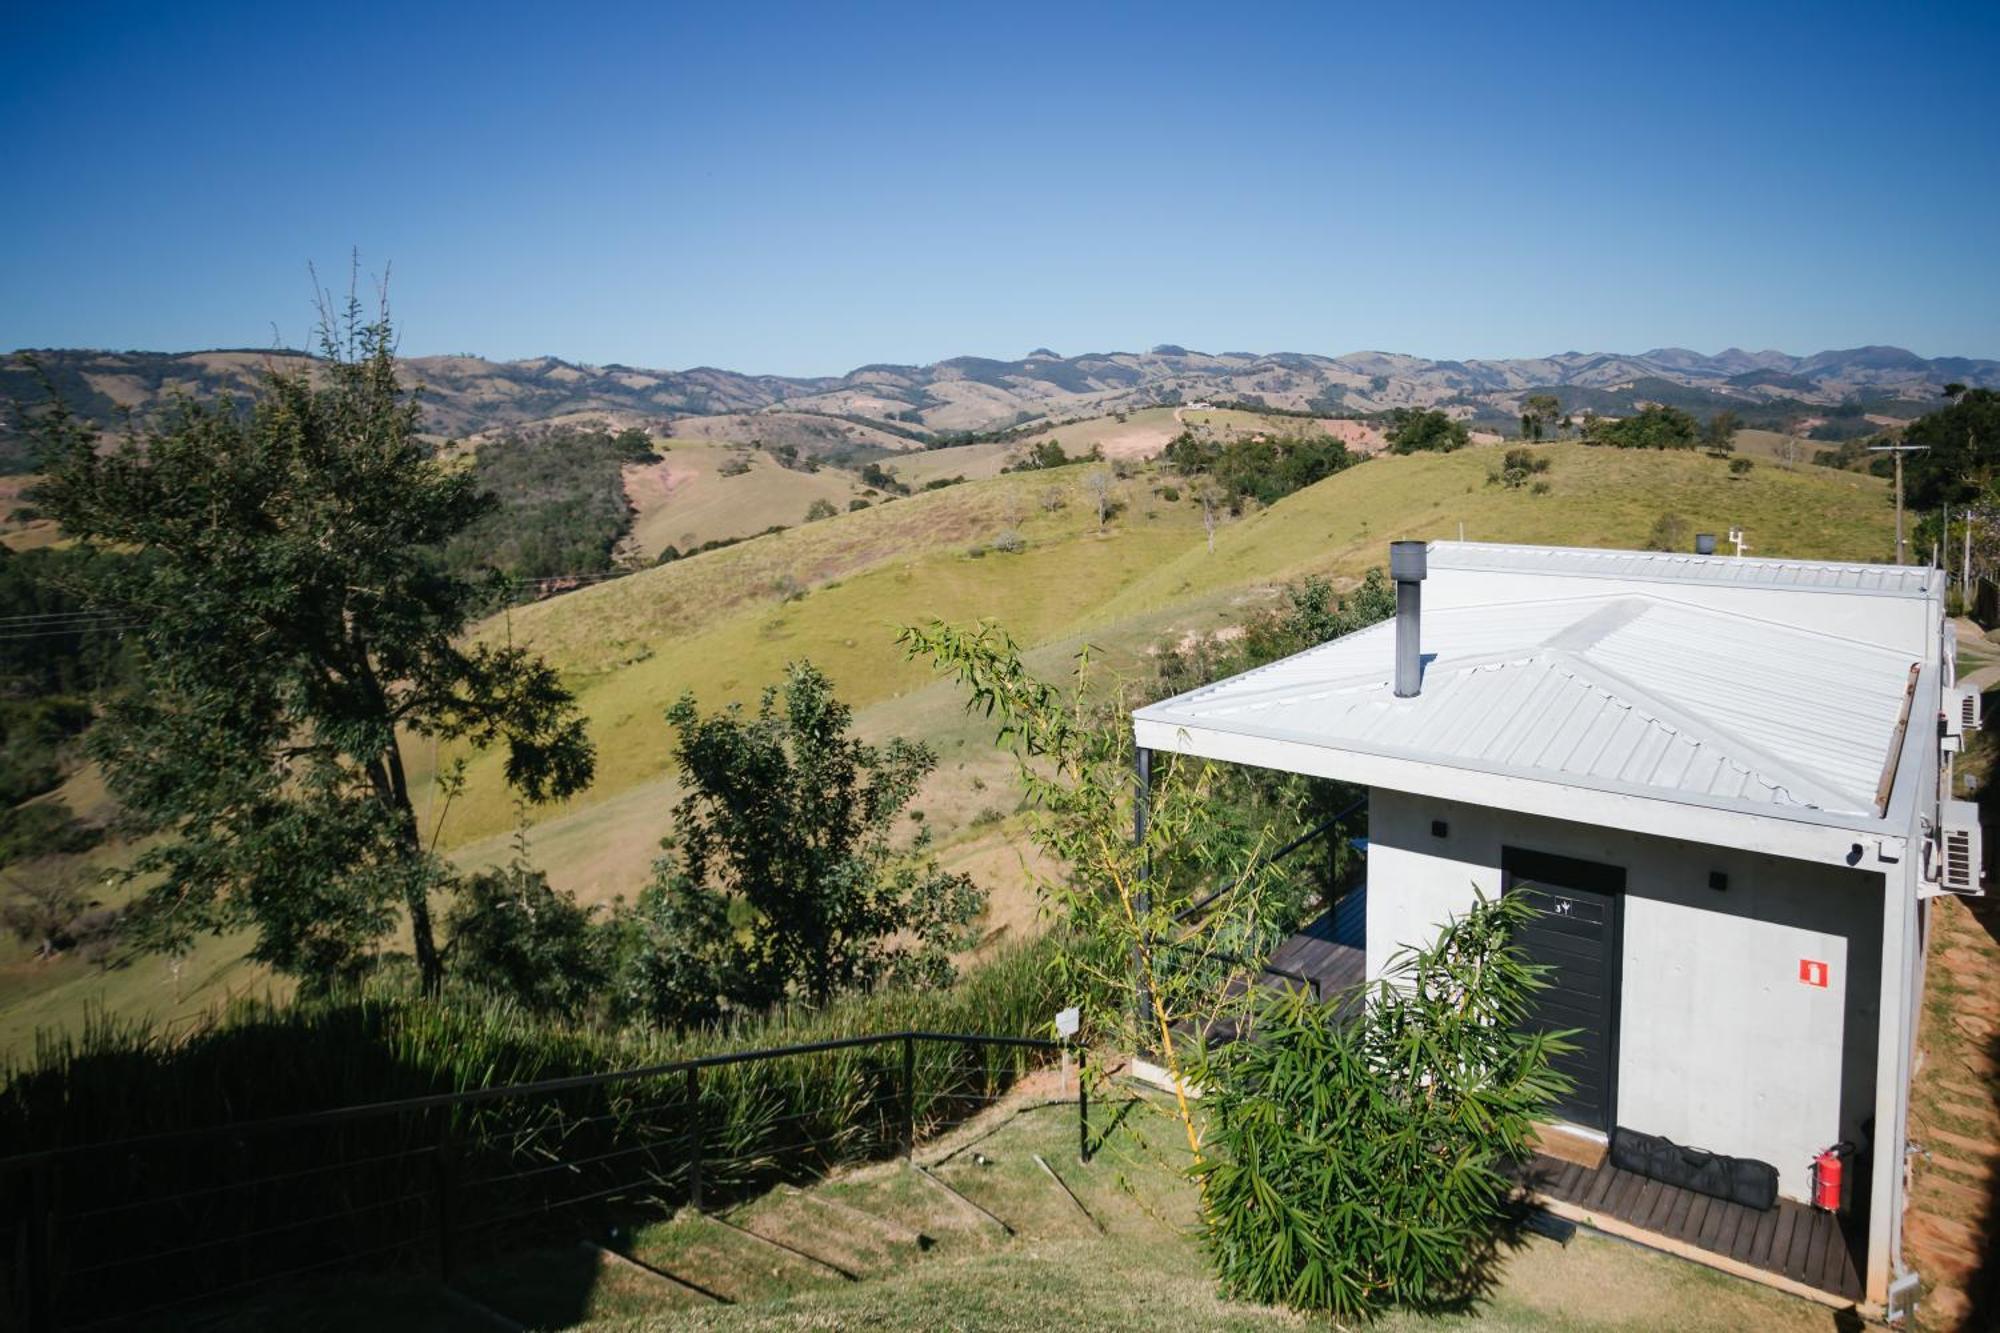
[10,304,978,1023]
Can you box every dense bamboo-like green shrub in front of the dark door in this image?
[1194,897,1568,1319]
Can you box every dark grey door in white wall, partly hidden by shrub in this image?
[1504,849,1624,1131]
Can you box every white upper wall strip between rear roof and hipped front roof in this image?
[1424,566,1940,660]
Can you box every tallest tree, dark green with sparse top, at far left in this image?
[34,300,594,989]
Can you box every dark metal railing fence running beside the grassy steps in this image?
[0,1033,1088,1333]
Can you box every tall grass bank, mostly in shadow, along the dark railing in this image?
[0,941,1096,1321]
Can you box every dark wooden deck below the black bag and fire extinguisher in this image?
[1516,1155,1866,1301]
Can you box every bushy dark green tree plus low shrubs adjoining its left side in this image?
[446,662,984,1027]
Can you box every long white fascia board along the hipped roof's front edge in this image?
[1132,717,1904,871]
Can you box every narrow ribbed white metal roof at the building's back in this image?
[1430,542,1942,596]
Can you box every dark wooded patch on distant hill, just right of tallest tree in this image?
[444,424,660,580]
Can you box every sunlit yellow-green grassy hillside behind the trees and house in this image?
[0,444,1894,1051]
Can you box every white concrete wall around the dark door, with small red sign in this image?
[1368,789,1884,1199]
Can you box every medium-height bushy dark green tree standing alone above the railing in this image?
[640,662,982,1015]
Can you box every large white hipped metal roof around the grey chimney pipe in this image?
[1134,592,1912,819]
